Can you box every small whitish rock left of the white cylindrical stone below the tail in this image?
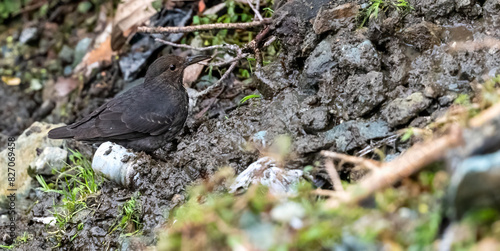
[30,147,68,175]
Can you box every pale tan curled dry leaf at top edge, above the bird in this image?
[111,0,156,51]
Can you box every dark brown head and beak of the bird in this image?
[146,55,210,85]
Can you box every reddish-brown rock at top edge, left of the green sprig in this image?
[313,3,359,34]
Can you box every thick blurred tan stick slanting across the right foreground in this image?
[327,125,462,207]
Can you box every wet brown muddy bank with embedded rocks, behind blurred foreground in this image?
[0,0,500,250]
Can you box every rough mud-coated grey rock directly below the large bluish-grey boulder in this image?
[335,71,389,118]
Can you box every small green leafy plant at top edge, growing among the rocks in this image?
[359,0,413,27]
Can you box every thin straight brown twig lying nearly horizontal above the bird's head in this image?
[137,18,272,33]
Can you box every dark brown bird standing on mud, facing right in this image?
[48,55,210,152]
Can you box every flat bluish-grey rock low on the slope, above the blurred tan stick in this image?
[324,120,390,152]
